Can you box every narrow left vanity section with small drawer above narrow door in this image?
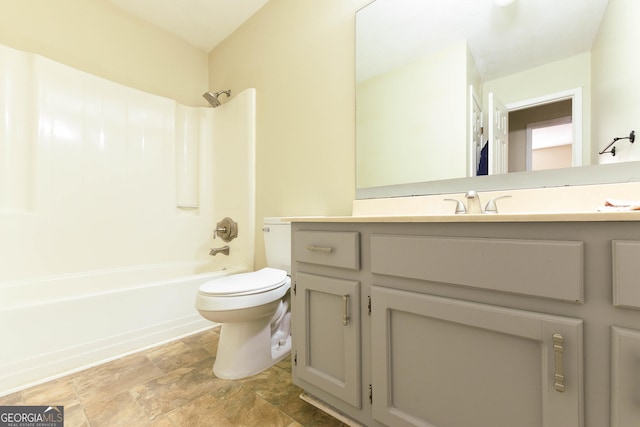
[292,231,362,410]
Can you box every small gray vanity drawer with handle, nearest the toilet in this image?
[293,231,360,270]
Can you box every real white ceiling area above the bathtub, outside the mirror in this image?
[108,0,269,52]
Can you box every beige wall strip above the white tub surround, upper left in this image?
[0,0,208,106]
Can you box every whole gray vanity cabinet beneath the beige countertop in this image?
[292,219,640,427]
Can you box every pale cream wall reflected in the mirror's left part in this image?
[356,41,468,188]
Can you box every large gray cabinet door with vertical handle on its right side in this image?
[371,286,584,427]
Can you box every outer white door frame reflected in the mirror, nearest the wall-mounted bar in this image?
[506,87,582,166]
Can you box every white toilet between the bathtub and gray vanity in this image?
[195,217,291,379]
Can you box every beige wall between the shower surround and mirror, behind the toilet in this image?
[209,0,370,267]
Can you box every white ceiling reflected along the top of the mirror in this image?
[356,0,609,82]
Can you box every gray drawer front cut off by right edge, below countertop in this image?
[612,240,640,309]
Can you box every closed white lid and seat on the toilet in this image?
[200,268,287,296]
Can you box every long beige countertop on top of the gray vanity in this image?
[283,211,640,223]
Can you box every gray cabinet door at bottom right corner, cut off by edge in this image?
[611,327,640,427]
